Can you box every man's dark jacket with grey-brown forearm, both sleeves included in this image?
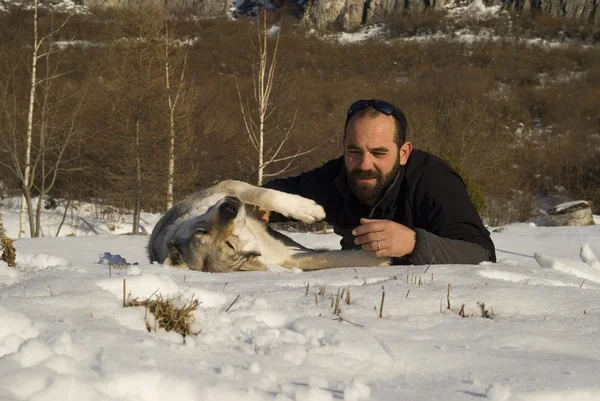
[265,149,496,265]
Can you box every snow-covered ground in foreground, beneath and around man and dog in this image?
[0,200,600,401]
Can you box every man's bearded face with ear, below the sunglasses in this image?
[344,114,412,206]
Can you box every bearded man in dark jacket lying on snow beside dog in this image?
[266,100,496,265]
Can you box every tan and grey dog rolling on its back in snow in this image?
[148,180,390,272]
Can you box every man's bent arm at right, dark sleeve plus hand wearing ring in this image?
[352,168,495,265]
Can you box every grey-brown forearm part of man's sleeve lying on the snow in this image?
[407,228,491,265]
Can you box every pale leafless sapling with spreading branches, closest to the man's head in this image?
[236,9,317,185]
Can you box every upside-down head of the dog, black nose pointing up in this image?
[165,196,267,272]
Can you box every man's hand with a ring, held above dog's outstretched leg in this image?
[352,219,416,258]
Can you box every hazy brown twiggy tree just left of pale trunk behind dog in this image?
[103,0,166,234]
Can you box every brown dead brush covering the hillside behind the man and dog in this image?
[0,12,600,225]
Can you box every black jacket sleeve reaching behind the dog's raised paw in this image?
[263,159,341,223]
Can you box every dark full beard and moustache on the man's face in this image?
[344,163,401,205]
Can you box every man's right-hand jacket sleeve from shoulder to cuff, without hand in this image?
[408,168,496,264]
